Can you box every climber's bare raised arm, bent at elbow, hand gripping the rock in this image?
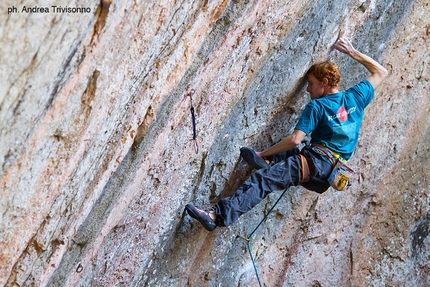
[334,37,388,89]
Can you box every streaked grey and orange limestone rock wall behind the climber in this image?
[0,0,430,286]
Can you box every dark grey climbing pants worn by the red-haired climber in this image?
[214,146,332,226]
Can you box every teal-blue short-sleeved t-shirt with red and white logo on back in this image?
[295,80,374,160]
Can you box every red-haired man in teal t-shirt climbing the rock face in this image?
[186,37,388,231]
